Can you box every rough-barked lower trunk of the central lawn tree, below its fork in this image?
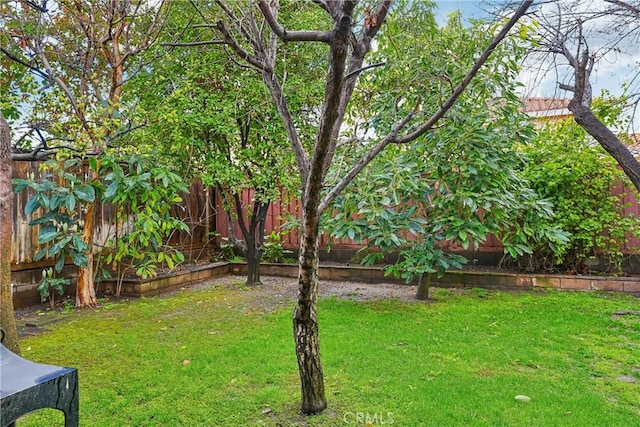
[293,214,327,415]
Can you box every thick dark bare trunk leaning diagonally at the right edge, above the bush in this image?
[569,98,640,191]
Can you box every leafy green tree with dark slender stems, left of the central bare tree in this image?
[138,17,296,286]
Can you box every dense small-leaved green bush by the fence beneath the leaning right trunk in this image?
[522,113,640,273]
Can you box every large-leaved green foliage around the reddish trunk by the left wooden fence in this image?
[13,153,188,299]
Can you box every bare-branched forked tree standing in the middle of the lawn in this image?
[186,0,532,414]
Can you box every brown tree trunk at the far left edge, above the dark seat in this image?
[0,112,20,354]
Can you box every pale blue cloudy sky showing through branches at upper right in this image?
[435,0,640,132]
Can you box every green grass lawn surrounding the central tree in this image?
[20,287,640,427]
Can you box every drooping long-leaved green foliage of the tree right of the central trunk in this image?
[326,8,566,281]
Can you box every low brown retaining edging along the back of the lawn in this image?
[12,262,640,308]
